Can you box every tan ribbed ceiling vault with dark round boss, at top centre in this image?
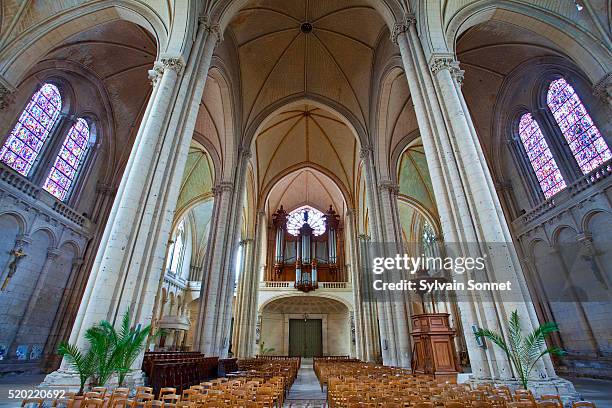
[229,0,385,131]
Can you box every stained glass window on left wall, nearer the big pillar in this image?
[43,118,90,201]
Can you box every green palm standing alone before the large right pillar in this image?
[474,310,566,389]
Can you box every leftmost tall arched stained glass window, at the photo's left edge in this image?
[0,84,62,176]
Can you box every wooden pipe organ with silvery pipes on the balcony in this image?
[266,205,346,292]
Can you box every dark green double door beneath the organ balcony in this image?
[289,319,323,357]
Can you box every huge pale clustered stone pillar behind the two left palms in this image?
[44,17,220,387]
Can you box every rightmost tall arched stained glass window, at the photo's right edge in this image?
[546,78,612,174]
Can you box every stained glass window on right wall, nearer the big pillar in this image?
[519,113,566,198]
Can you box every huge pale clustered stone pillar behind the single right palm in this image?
[392,16,573,394]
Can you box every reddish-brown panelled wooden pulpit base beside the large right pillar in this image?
[410,313,460,383]
